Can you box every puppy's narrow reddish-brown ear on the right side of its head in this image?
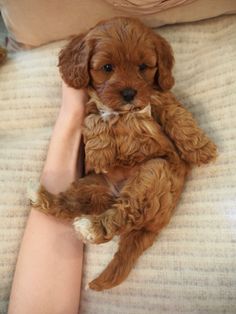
[155,35,175,91]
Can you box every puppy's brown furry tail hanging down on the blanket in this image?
[89,229,156,291]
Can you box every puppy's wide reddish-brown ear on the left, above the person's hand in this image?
[58,34,92,89]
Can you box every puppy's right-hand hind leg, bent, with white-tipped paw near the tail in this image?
[74,159,184,244]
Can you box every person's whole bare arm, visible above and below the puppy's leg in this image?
[8,83,87,314]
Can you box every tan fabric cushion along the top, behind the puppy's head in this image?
[0,0,236,48]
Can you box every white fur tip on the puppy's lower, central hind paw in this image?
[73,218,96,242]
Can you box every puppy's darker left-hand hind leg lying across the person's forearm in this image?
[32,174,114,220]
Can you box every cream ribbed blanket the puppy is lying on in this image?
[0,16,236,314]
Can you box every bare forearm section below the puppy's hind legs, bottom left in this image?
[8,209,83,314]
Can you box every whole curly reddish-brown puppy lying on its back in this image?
[32,18,216,290]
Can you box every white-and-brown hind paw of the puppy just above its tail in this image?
[73,215,113,244]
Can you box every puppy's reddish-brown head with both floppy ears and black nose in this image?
[59,18,174,110]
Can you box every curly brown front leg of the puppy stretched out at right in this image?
[152,93,217,165]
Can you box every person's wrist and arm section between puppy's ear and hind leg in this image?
[41,82,86,193]
